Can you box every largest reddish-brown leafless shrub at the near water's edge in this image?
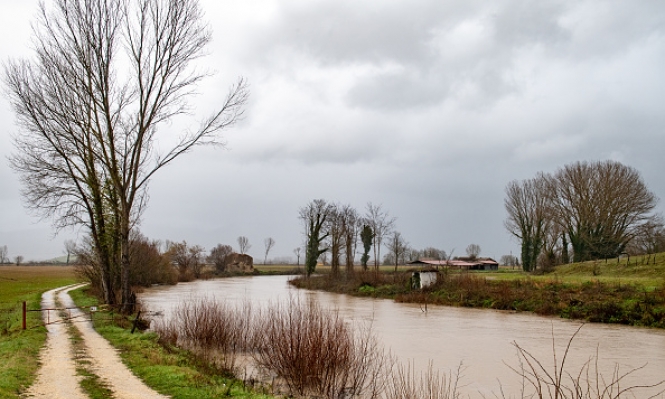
[254,298,387,398]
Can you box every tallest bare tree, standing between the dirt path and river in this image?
[5,0,248,312]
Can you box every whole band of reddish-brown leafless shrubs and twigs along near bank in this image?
[148,298,665,399]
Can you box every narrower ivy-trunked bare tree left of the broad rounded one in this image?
[504,175,550,271]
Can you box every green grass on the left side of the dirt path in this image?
[0,266,76,398]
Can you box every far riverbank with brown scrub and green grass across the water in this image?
[291,254,665,328]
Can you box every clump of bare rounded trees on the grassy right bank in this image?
[504,161,665,271]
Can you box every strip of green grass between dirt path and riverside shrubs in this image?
[70,288,272,399]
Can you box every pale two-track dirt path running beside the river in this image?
[26,286,168,399]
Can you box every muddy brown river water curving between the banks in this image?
[140,276,665,398]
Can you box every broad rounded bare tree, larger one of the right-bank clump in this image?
[549,161,657,262]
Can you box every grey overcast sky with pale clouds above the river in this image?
[0,0,665,261]
